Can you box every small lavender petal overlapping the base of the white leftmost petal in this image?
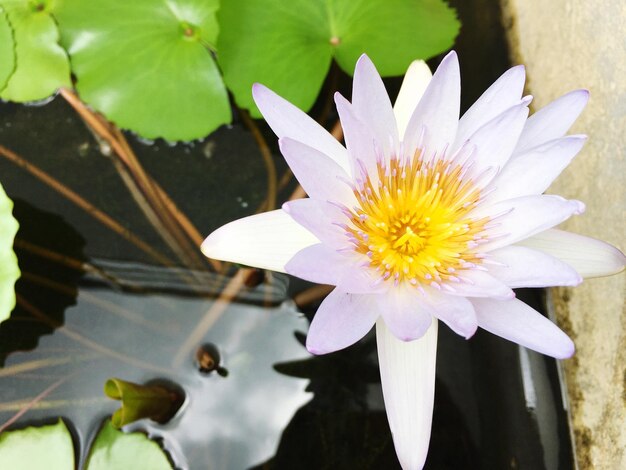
[283,198,348,249]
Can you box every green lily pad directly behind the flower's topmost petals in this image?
[218,0,459,117]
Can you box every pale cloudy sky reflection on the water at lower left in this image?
[0,263,312,468]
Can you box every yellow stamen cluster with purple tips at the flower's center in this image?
[346,151,489,287]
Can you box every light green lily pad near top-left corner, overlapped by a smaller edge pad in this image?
[0,0,71,102]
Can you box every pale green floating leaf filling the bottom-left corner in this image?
[0,420,74,470]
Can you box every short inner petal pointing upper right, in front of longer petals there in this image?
[468,102,528,181]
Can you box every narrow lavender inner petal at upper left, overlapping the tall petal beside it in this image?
[335,93,380,177]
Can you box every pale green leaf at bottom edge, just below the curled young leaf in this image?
[85,420,172,470]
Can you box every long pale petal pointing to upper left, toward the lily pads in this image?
[252,83,350,173]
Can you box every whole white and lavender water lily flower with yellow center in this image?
[202,52,625,469]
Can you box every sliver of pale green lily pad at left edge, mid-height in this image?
[0,185,20,324]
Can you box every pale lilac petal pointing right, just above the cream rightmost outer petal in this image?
[470,195,585,251]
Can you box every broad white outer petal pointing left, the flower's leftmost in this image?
[202,209,319,272]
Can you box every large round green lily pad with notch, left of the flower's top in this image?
[54,0,231,140]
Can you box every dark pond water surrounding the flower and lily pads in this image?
[0,2,573,469]
